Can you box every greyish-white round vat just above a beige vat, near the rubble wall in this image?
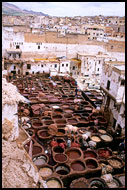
[32,155,48,167]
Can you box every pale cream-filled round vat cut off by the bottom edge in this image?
[46,177,63,188]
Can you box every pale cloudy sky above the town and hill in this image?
[9,2,125,16]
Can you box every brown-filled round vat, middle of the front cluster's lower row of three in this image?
[71,160,85,171]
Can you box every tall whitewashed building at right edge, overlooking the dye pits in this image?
[101,62,125,133]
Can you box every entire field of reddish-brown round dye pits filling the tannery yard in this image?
[3,74,124,188]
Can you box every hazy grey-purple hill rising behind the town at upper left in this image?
[2,2,48,16]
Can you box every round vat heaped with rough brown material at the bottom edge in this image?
[70,177,88,188]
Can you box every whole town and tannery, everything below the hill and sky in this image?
[2,2,125,188]
